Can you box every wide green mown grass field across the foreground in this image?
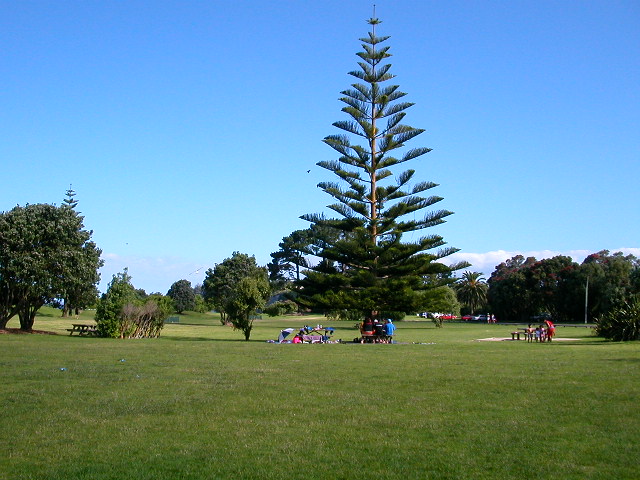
[0,310,640,480]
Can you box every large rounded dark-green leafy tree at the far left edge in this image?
[0,204,102,330]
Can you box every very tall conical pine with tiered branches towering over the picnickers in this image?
[299,18,465,316]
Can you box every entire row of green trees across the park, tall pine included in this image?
[11,18,639,340]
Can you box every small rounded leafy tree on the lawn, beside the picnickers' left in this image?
[202,252,270,340]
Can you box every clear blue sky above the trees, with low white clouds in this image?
[0,0,640,293]
